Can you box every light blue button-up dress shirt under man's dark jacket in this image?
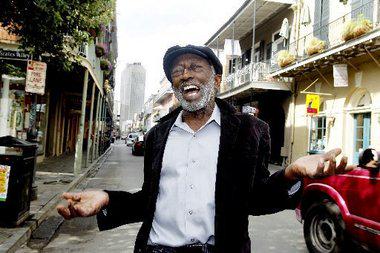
[148,105,220,247]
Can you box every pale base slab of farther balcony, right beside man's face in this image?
[218,81,291,99]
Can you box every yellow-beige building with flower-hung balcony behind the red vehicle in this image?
[271,0,380,163]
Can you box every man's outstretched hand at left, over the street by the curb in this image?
[57,190,109,220]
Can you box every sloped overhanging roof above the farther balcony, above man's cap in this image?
[205,0,295,49]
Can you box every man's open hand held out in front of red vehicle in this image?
[285,148,356,181]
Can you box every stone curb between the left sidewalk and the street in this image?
[0,146,112,253]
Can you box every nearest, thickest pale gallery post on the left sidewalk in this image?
[74,69,88,176]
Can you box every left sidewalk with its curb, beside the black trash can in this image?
[0,146,112,253]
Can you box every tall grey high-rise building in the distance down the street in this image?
[120,62,146,131]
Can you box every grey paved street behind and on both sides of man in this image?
[17,141,307,253]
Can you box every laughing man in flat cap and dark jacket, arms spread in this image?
[58,45,351,253]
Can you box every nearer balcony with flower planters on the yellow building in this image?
[270,1,380,77]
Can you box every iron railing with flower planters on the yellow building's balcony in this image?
[270,0,377,72]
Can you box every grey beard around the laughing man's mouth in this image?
[173,75,216,112]
